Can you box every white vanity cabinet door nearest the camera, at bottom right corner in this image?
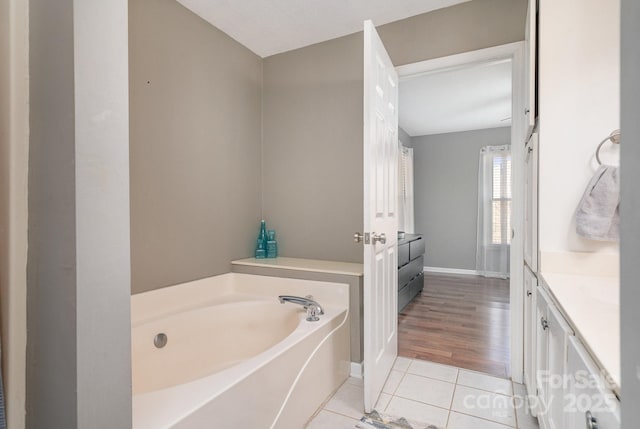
[564,337,620,429]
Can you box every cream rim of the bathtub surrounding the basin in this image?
[132,273,350,428]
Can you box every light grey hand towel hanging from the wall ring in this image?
[576,165,620,241]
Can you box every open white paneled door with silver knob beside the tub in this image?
[363,21,398,412]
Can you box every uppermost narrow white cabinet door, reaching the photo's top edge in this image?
[524,0,538,141]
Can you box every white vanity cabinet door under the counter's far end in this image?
[535,287,573,429]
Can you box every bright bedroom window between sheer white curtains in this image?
[491,154,511,244]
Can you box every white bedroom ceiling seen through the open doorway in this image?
[398,60,511,136]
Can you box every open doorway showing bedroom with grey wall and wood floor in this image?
[397,44,524,382]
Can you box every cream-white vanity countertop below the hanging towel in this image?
[541,272,620,391]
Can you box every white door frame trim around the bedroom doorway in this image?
[396,42,526,383]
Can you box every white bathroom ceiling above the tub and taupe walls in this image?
[178,0,469,58]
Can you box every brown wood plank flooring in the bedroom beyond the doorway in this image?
[398,273,510,377]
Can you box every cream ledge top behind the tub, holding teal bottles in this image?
[231,257,364,276]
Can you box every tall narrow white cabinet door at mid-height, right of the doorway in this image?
[524,132,538,273]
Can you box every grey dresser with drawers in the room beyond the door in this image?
[398,234,425,313]
